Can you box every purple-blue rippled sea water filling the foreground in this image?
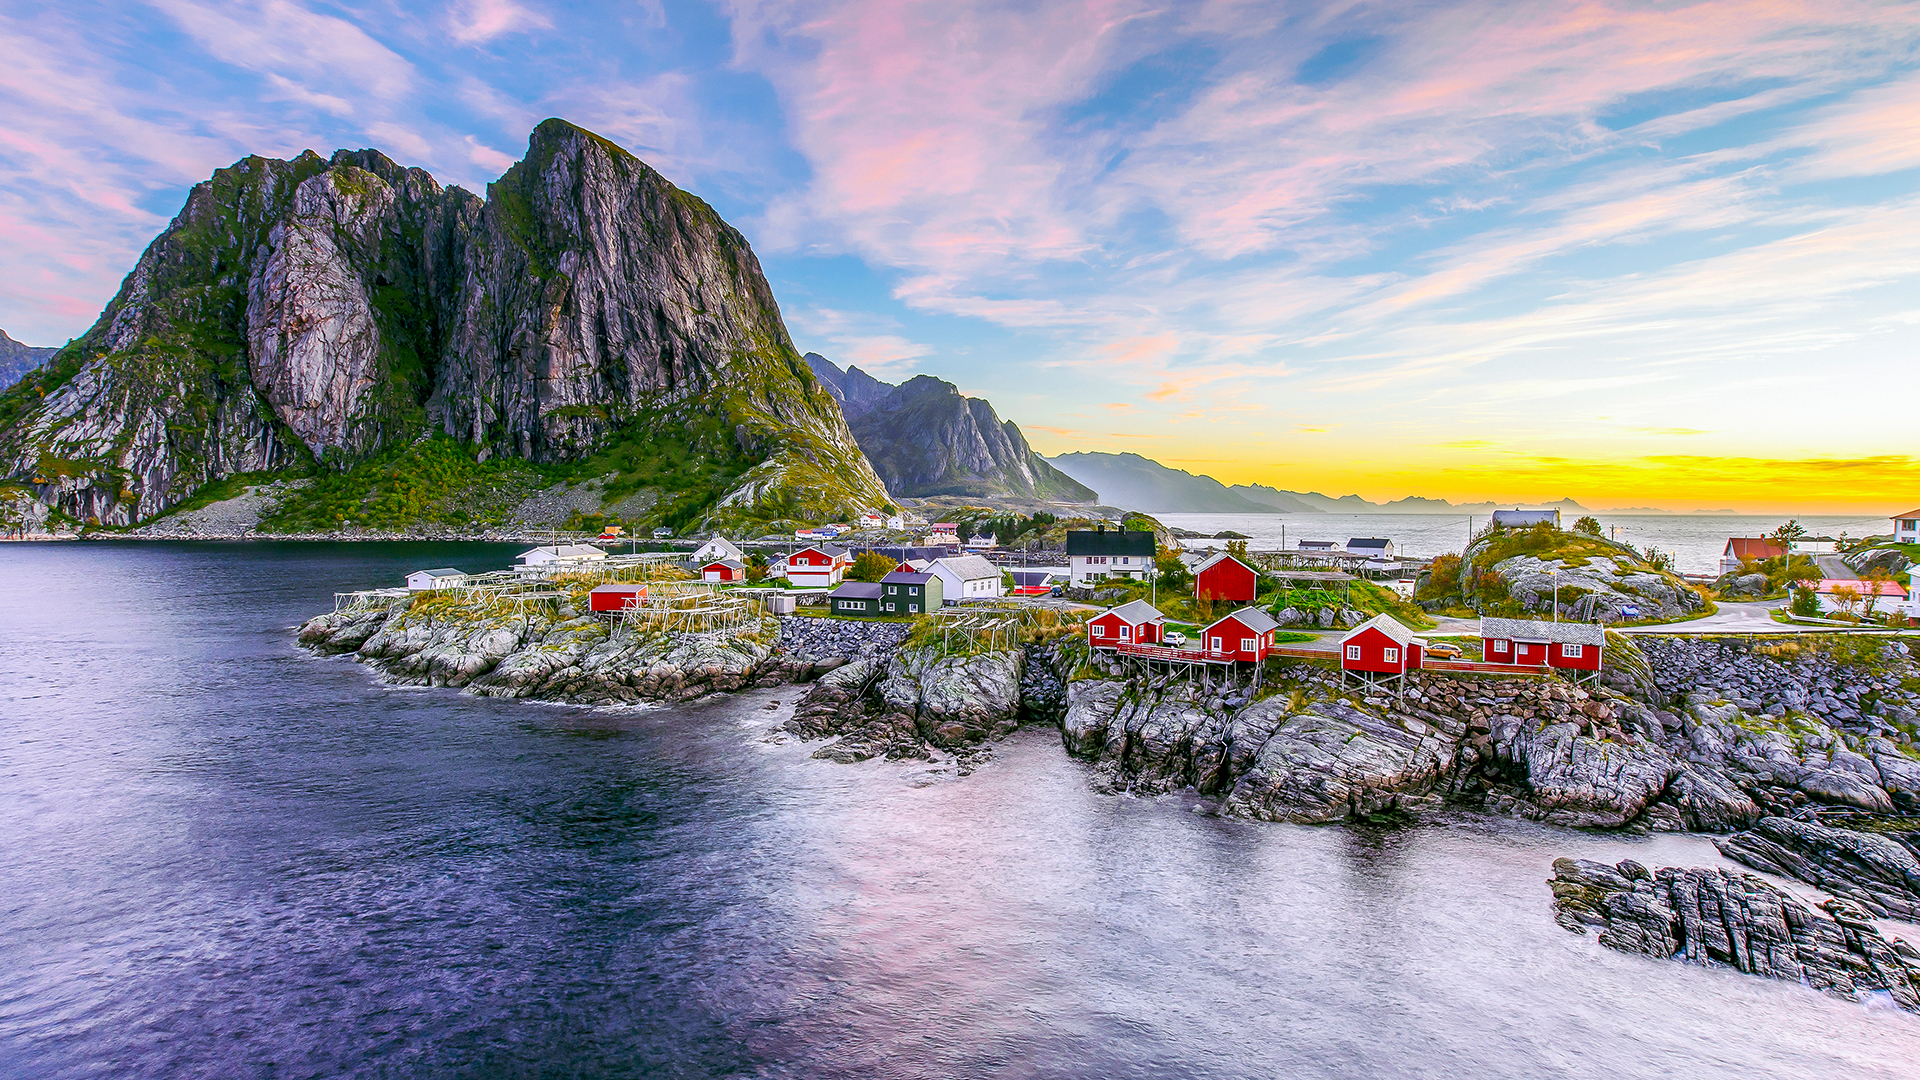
[0,542,1920,1080]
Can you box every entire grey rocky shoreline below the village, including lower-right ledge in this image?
[300,578,1920,1011]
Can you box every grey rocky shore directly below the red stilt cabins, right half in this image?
[1062,640,1920,832]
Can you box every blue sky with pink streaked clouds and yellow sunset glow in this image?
[0,0,1920,513]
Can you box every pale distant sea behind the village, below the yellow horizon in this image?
[1154,513,1893,575]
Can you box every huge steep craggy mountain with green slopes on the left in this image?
[0,119,889,525]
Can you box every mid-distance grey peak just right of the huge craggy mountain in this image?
[806,352,1096,503]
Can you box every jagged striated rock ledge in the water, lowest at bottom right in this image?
[1551,859,1920,1013]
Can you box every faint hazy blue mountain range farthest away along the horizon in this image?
[1052,445,1586,513]
